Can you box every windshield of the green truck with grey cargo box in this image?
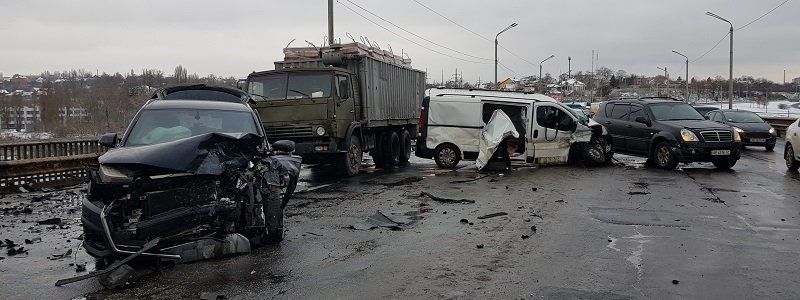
[247,72,333,101]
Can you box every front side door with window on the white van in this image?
[531,102,578,164]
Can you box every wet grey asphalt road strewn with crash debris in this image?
[0,143,800,299]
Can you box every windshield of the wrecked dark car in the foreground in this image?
[125,109,258,146]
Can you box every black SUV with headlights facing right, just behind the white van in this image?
[594,97,741,169]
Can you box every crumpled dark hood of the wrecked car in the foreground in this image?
[98,133,264,175]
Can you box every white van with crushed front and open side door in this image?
[415,88,612,168]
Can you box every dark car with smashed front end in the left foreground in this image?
[81,85,301,269]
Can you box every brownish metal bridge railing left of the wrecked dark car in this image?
[0,138,108,192]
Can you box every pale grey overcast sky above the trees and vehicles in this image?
[0,0,800,82]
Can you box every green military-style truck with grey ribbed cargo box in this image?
[245,43,425,176]
